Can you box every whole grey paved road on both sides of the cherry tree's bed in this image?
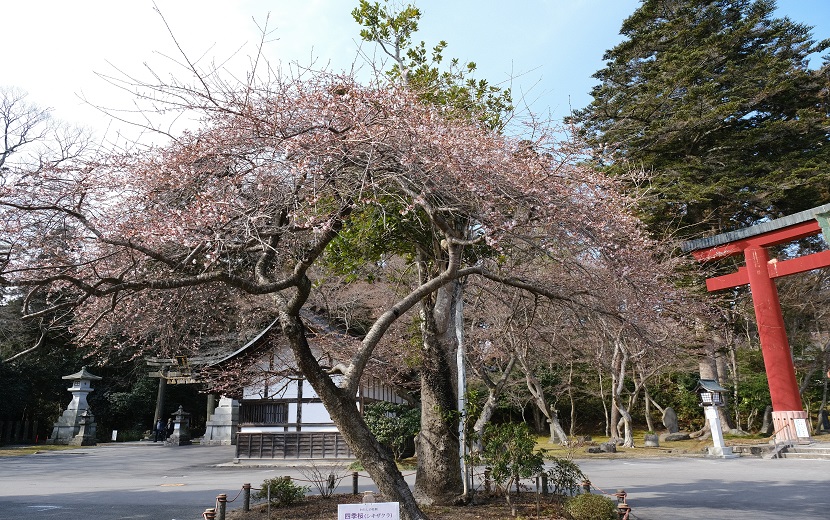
[0,443,830,520]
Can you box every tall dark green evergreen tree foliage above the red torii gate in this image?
[573,0,830,236]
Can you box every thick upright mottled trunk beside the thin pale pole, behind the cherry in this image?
[415,282,464,504]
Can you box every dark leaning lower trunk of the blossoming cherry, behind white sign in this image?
[280,312,427,520]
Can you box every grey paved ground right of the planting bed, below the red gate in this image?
[578,458,830,520]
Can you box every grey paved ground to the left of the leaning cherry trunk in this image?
[0,442,354,520]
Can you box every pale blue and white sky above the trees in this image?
[0,0,830,138]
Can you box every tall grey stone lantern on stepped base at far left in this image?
[46,367,102,446]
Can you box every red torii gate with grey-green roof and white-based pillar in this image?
[681,204,830,441]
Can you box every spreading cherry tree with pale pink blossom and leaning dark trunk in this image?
[0,33,676,518]
